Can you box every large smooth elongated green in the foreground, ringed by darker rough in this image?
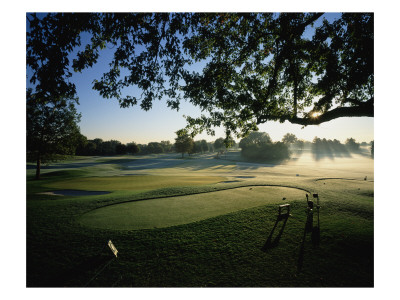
[79,186,306,230]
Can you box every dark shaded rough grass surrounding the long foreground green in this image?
[26,156,374,287]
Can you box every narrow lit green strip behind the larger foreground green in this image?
[47,175,226,191]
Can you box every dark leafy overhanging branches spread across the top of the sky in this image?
[27,13,374,141]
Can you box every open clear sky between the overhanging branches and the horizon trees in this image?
[26,13,374,143]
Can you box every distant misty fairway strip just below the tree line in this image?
[27,150,374,185]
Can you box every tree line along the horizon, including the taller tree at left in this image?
[27,112,374,179]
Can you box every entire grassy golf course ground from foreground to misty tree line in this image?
[26,153,374,287]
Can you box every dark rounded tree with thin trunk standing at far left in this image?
[26,90,82,179]
